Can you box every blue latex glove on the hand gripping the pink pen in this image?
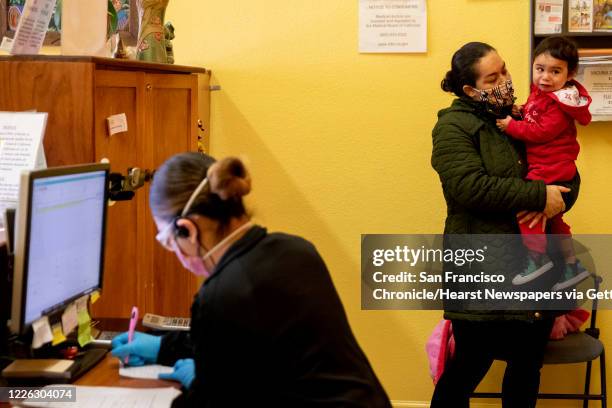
[111,332,161,366]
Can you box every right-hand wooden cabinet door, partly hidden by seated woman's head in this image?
[144,74,199,316]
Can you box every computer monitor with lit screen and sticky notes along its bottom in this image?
[9,164,109,334]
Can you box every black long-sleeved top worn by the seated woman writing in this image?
[158,226,391,408]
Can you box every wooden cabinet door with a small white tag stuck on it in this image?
[93,70,146,317]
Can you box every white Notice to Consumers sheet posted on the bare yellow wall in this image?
[359,0,427,53]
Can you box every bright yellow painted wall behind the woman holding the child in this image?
[167,0,612,406]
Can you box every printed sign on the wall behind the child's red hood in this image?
[576,63,612,121]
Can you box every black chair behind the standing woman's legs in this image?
[471,276,607,408]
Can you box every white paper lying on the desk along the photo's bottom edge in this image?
[22,385,181,408]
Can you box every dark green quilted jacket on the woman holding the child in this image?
[431,97,580,320]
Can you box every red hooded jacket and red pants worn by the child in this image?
[506,80,591,253]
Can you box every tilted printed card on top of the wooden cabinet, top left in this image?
[11,0,55,55]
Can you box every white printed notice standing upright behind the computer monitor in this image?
[0,112,47,226]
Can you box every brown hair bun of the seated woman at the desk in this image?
[207,157,251,200]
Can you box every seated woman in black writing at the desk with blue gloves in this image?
[112,153,391,408]
